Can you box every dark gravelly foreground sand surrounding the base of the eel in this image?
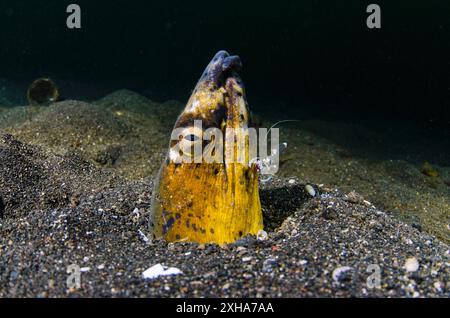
[0,135,450,297]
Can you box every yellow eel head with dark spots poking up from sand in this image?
[150,51,263,244]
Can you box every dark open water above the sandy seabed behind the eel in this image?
[0,0,450,129]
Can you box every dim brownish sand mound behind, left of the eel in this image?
[0,97,170,179]
